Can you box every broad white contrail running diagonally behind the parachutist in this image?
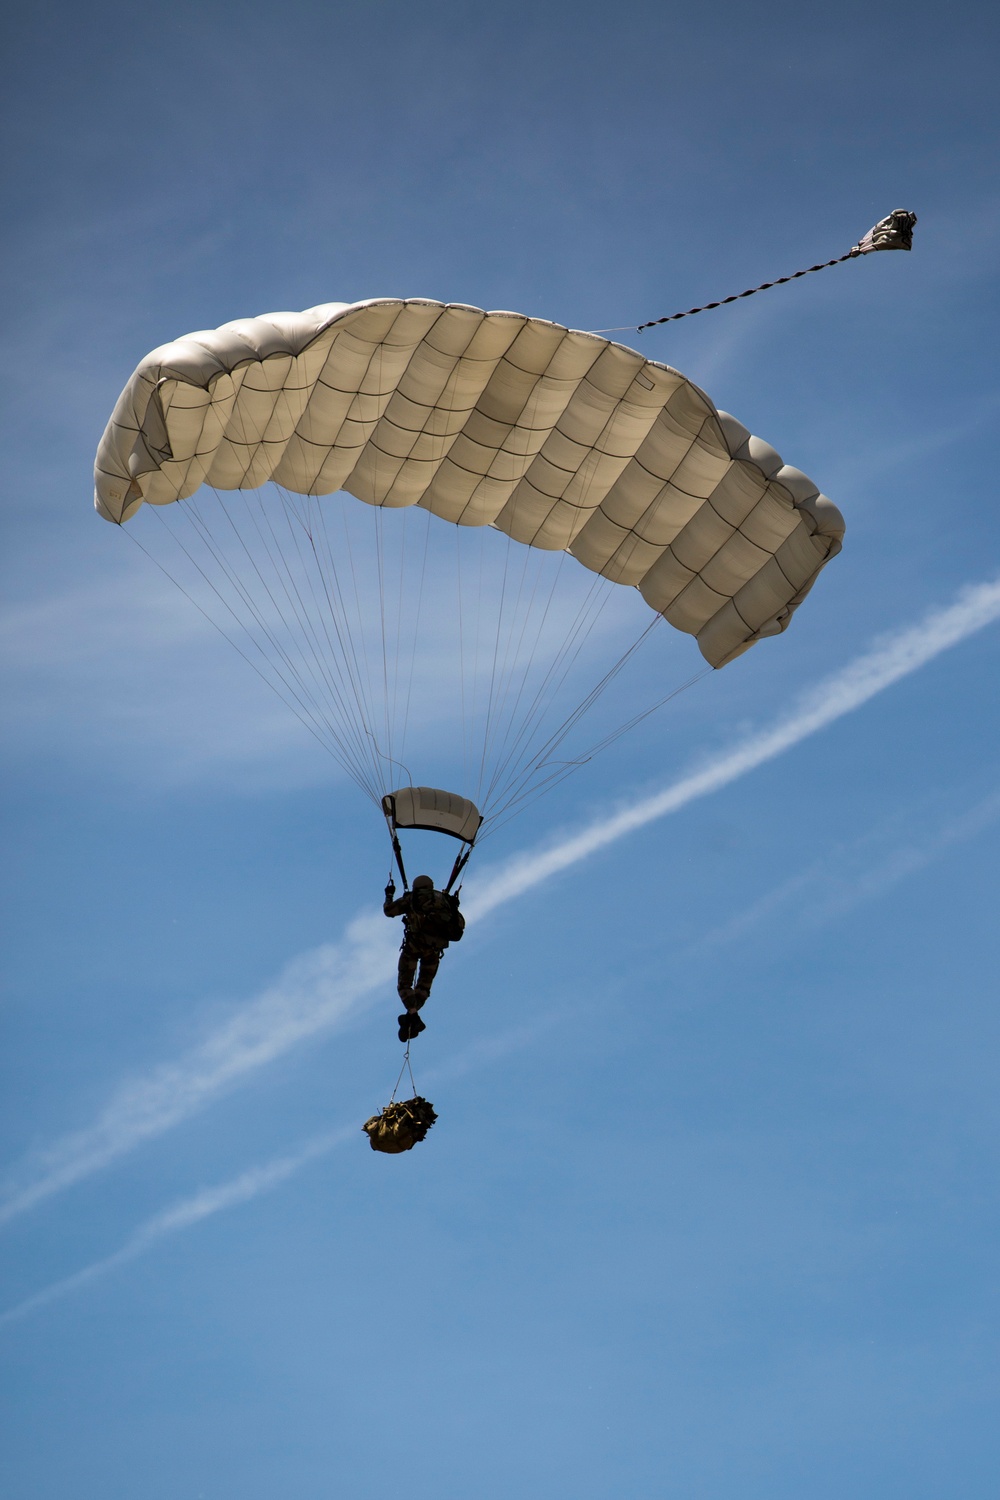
[0,579,1000,1224]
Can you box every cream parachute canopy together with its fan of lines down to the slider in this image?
[96,299,844,870]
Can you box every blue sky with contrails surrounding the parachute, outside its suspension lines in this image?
[0,0,1000,1500]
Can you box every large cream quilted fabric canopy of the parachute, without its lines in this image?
[94,299,844,666]
